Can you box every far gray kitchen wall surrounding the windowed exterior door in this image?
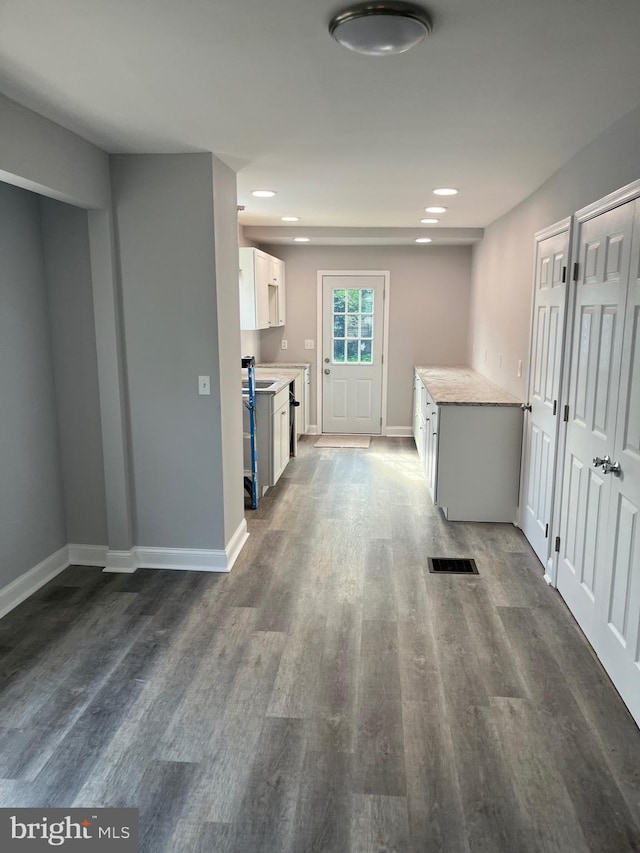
[261,241,471,427]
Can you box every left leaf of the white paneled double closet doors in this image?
[558,204,633,652]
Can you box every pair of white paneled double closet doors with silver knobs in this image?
[558,196,640,723]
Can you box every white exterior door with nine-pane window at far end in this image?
[321,274,385,435]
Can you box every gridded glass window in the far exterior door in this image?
[331,288,374,364]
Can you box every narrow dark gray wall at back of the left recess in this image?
[40,199,108,545]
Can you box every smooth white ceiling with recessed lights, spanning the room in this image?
[0,0,640,242]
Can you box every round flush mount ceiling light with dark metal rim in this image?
[329,0,433,56]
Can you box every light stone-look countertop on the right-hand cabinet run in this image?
[416,366,521,406]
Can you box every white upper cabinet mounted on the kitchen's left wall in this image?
[240,247,285,331]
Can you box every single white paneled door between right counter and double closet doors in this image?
[520,219,570,569]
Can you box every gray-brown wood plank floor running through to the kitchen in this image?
[0,439,640,853]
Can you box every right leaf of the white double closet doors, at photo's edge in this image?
[596,201,640,723]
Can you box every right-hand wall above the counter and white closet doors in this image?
[468,102,640,399]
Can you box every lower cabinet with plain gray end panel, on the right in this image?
[413,368,522,522]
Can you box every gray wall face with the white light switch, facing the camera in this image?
[111,154,229,549]
